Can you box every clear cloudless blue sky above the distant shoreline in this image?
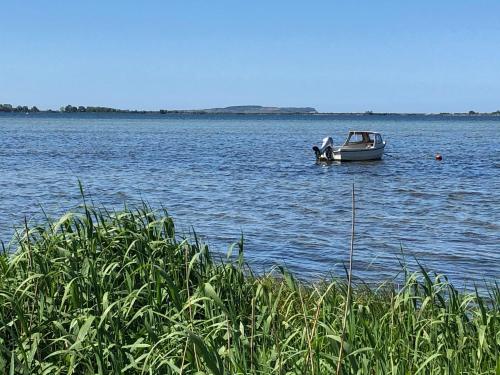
[0,0,500,112]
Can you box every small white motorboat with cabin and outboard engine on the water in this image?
[313,130,385,161]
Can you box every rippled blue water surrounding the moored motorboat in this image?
[0,114,500,285]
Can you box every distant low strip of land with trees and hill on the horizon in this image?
[0,104,500,116]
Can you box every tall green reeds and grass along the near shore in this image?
[0,206,500,375]
